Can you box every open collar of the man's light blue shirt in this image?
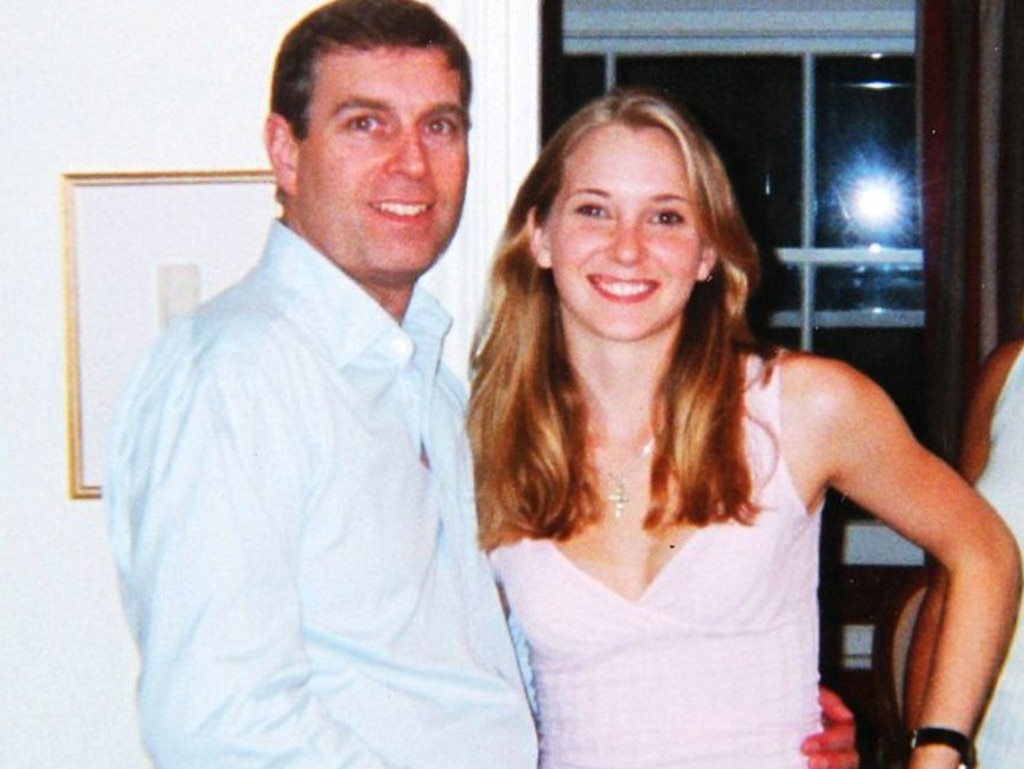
[261,221,452,370]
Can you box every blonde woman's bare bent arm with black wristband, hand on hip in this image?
[782,355,1020,767]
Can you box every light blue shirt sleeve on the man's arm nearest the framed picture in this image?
[104,342,399,769]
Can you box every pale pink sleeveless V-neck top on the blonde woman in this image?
[492,361,820,769]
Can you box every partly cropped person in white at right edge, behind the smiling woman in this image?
[906,339,1024,769]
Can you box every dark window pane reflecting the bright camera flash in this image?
[814,56,919,248]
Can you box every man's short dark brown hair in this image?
[270,0,472,139]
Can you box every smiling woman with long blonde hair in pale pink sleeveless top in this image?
[469,91,1019,769]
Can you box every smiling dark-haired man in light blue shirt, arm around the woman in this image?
[104,0,855,769]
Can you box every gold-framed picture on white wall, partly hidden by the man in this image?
[62,171,278,499]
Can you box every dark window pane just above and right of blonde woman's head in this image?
[616,55,803,248]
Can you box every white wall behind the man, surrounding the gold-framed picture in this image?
[0,0,539,769]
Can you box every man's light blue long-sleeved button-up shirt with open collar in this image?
[103,222,537,769]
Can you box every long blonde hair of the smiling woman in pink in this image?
[469,89,768,550]
